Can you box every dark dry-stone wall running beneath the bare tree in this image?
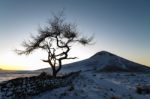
[0,72,79,99]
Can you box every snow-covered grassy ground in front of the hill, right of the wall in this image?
[25,71,150,99]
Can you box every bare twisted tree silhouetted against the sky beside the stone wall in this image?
[15,12,93,77]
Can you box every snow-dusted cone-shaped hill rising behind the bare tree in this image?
[38,51,150,72]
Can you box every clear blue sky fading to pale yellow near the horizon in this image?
[0,0,150,70]
